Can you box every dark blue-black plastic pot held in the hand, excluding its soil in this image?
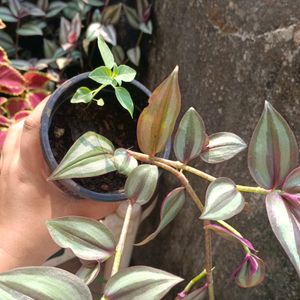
[40,72,171,202]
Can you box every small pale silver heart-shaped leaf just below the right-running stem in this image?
[200,177,245,220]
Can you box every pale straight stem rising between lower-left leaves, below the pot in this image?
[111,201,132,277]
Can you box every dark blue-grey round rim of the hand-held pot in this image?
[40,72,171,202]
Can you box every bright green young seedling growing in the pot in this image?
[71,36,136,117]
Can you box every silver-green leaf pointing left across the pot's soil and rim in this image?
[49,131,116,180]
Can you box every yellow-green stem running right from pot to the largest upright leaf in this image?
[128,150,270,195]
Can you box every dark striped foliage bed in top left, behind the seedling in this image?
[0,0,152,78]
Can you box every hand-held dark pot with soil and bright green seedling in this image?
[40,37,169,201]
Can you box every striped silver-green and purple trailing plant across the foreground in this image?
[0,67,300,300]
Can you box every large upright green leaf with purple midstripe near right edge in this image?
[248,101,298,189]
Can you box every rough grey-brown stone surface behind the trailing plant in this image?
[133,0,300,300]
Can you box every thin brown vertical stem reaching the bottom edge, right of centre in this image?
[204,220,215,300]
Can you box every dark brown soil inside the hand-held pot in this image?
[49,87,147,193]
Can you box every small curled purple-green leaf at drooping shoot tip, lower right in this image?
[233,254,265,288]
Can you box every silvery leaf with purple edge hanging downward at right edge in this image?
[266,192,300,276]
